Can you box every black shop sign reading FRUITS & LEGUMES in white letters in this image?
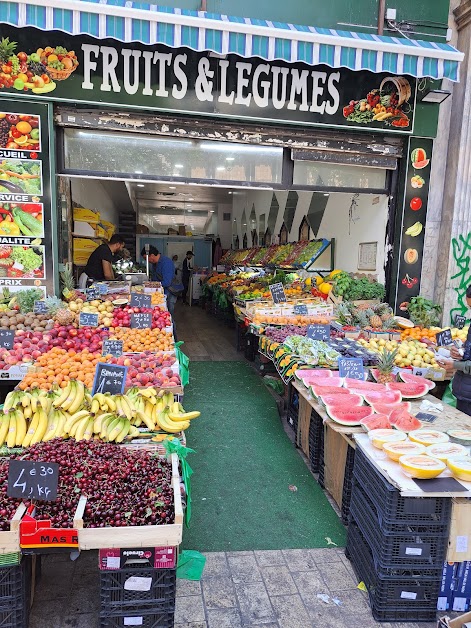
[0,26,416,133]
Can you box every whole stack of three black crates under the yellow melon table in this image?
[346,448,451,622]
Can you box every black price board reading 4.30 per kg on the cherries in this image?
[7,460,59,501]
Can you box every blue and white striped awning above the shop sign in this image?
[0,0,464,81]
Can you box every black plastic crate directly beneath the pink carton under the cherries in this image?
[100,567,176,612]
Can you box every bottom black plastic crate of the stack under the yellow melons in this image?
[345,519,441,622]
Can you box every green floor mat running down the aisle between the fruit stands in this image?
[183,362,345,552]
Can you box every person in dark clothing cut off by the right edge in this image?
[437,285,471,416]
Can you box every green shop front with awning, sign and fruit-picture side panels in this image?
[0,0,462,306]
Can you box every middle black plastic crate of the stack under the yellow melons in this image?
[350,484,448,569]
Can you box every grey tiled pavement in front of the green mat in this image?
[30,548,436,628]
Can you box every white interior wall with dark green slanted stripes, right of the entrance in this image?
[232,190,388,281]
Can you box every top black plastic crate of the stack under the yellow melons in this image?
[353,447,451,533]
